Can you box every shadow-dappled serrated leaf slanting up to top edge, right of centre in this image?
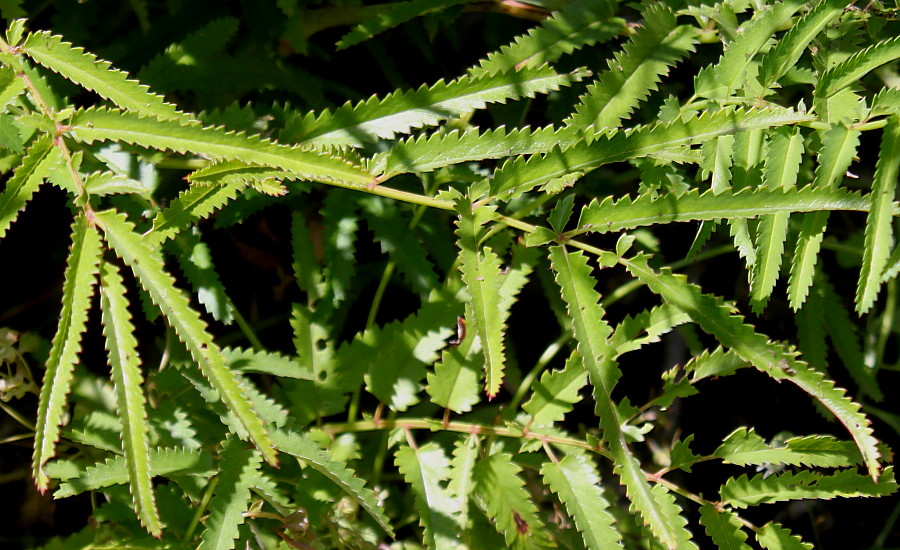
[469,0,625,75]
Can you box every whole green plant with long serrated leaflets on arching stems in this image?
[0,0,900,549]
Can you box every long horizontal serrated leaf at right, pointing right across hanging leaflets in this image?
[566,186,871,237]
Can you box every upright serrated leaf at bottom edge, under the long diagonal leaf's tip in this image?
[198,437,262,550]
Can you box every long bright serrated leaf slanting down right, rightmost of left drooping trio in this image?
[95,210,278,465]
